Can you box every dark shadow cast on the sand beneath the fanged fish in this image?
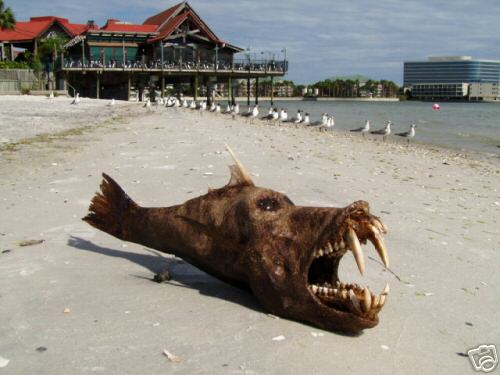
[68,236,265,313]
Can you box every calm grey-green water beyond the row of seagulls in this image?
[237,101,500,156]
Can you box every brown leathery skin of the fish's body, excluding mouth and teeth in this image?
[83,168,386,332]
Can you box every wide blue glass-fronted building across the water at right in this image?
[403,56,500,99]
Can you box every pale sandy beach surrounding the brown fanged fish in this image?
[0,96,500,374]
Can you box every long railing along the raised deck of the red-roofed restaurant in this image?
[56,56,288,73]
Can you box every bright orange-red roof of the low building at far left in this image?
[0,16,89,42]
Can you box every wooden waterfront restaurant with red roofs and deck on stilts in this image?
[0,1,287,100]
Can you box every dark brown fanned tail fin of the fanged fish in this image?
[82,173,140,240]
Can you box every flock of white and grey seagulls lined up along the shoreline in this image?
[67,93,416,145]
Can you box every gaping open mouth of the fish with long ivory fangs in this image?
[307,214,389,320]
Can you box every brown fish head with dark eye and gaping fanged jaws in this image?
[207,148,389,332]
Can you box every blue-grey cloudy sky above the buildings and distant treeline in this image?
[5,0,500,84]
